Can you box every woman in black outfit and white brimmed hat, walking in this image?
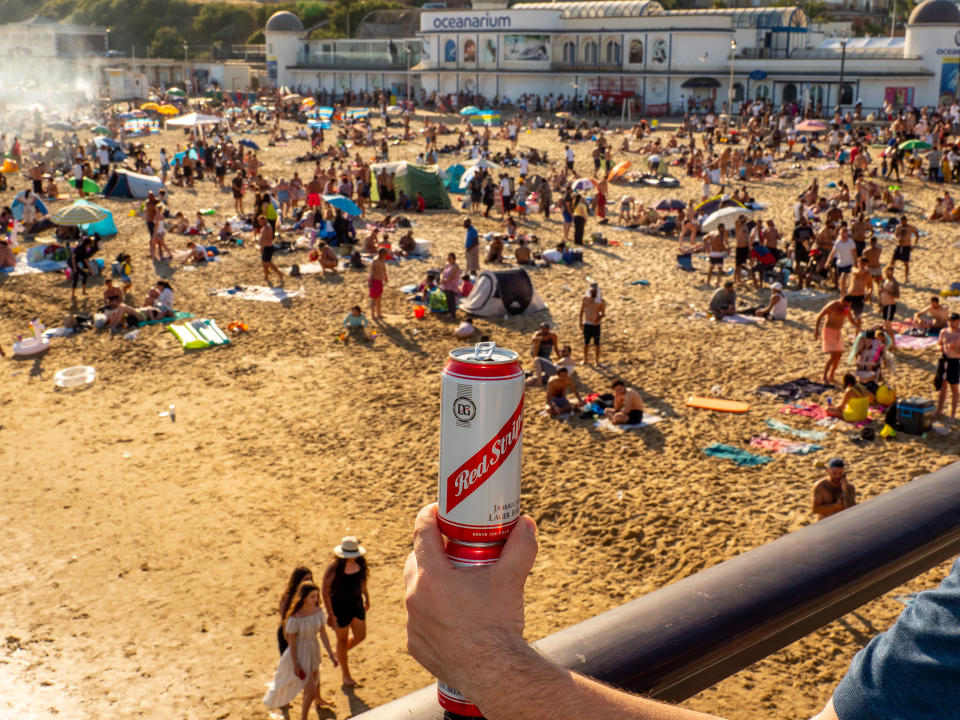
[323,535,370,687]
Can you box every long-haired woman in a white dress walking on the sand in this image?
[263,583,337,720]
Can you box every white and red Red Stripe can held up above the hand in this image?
[438,343,524,543]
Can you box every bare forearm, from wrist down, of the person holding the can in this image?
[469,646,716,720]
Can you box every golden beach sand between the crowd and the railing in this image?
[0,109,960,720]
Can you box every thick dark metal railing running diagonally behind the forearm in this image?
[350,463,960,720]
